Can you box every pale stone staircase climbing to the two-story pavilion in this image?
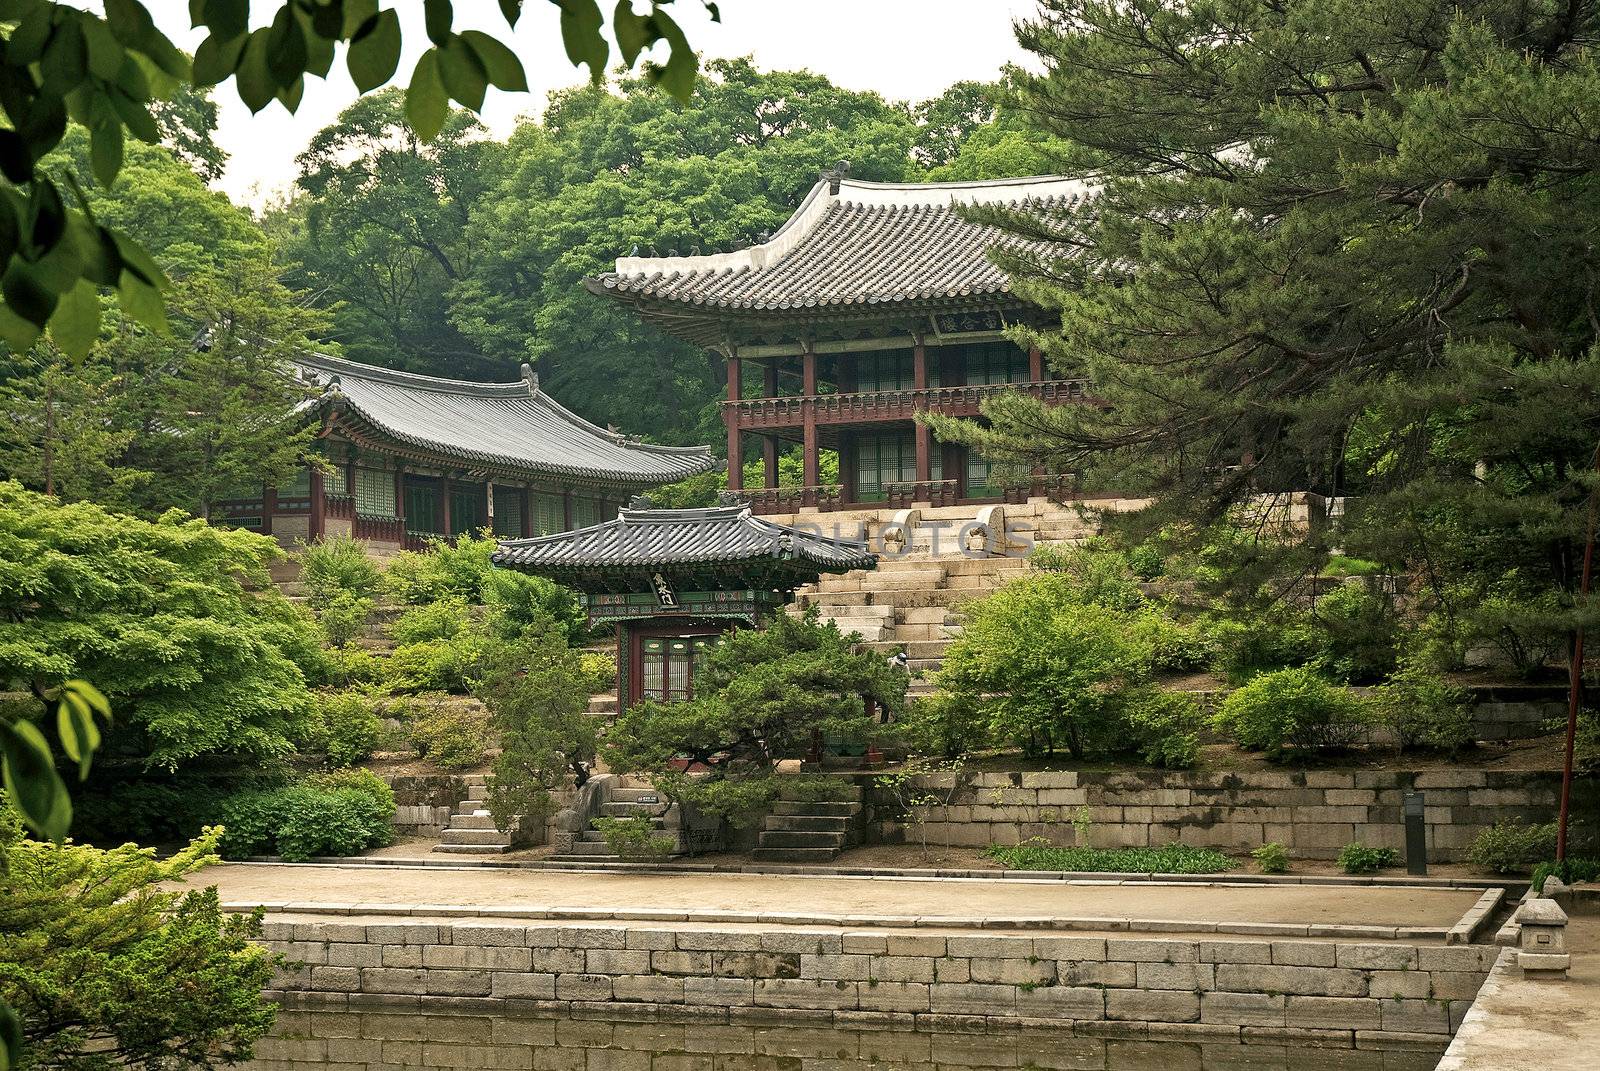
[774,499,1094,681]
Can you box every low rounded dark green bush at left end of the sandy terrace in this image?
[219,770,395,863]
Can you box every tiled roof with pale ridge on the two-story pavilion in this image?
[587,178,1091,328]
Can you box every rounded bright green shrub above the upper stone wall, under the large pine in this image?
[1211,669,1366,757]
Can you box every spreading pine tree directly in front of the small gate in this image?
[602,615,909,823]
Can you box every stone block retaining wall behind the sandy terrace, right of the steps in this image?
[869,770,1560,863]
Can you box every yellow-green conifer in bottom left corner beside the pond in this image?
[0,810,278,1071]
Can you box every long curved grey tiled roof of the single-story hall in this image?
[296,355,718,487]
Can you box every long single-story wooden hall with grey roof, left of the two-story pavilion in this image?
[222,355,720,552]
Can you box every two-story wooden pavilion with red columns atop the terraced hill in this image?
[587,166,1090,512]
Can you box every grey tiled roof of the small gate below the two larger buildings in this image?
[494,506,878,573]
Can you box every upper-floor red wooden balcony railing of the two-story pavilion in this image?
[722,379,1090,427]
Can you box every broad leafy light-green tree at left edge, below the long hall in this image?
[0,483,322,768]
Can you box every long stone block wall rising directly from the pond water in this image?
[262,919,1498,1045]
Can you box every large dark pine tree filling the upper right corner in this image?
[931,0,1600,675]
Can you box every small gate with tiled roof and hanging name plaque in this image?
[494,506,878,709]
